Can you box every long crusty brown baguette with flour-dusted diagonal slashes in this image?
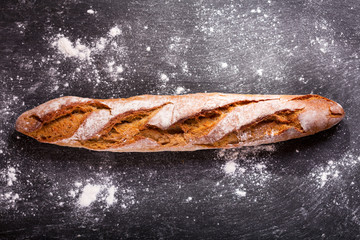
[16,93,344,152]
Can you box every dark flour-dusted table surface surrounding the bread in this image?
[0,0,360,239]
